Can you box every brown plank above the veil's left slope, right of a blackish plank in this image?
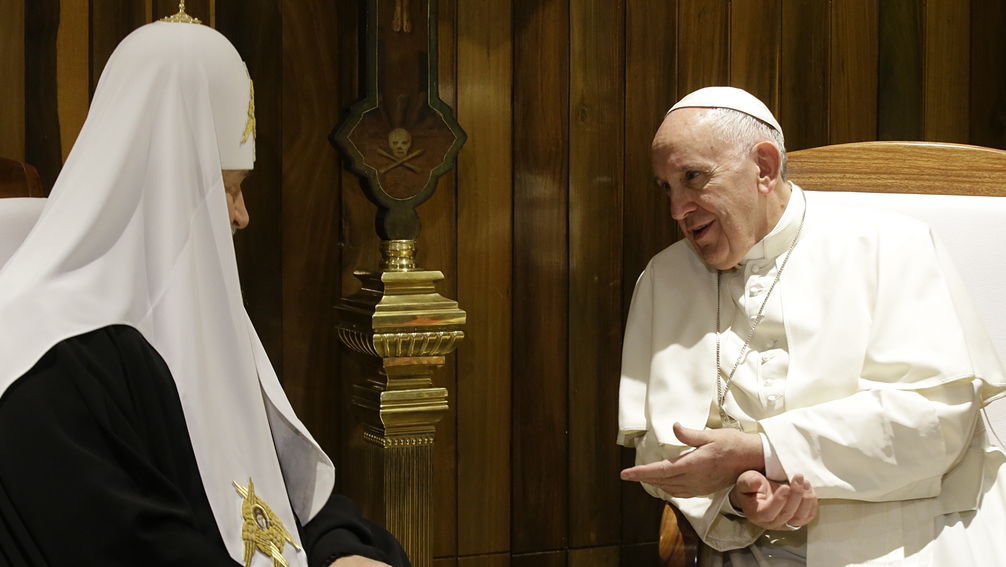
[56,0,90,162]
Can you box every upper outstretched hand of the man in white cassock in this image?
[622,423,765,498]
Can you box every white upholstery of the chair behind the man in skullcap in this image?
[807,191,1006,448]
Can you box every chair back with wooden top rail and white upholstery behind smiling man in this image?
[789,142,1006,448]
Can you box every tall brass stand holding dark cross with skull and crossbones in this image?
[329,0,466,567]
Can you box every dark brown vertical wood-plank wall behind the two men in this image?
[0,0,1006,567]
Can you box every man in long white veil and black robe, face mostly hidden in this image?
[0,12,409,567]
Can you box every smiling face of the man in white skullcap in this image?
[652,108,772,269]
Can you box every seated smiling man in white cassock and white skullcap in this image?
[619,86,1006,567]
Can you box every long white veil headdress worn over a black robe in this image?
[0,22,334,565]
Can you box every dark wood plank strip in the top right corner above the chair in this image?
[970,0,1006,149]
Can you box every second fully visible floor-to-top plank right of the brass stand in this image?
[511,0,569,553]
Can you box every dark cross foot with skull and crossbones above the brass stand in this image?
[329,0,467,240]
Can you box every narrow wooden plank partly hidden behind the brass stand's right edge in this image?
[426,0,460,557]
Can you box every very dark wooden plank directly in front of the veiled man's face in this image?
[217,0,284,369]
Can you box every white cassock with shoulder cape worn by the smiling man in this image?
[619,186,1006,567]
